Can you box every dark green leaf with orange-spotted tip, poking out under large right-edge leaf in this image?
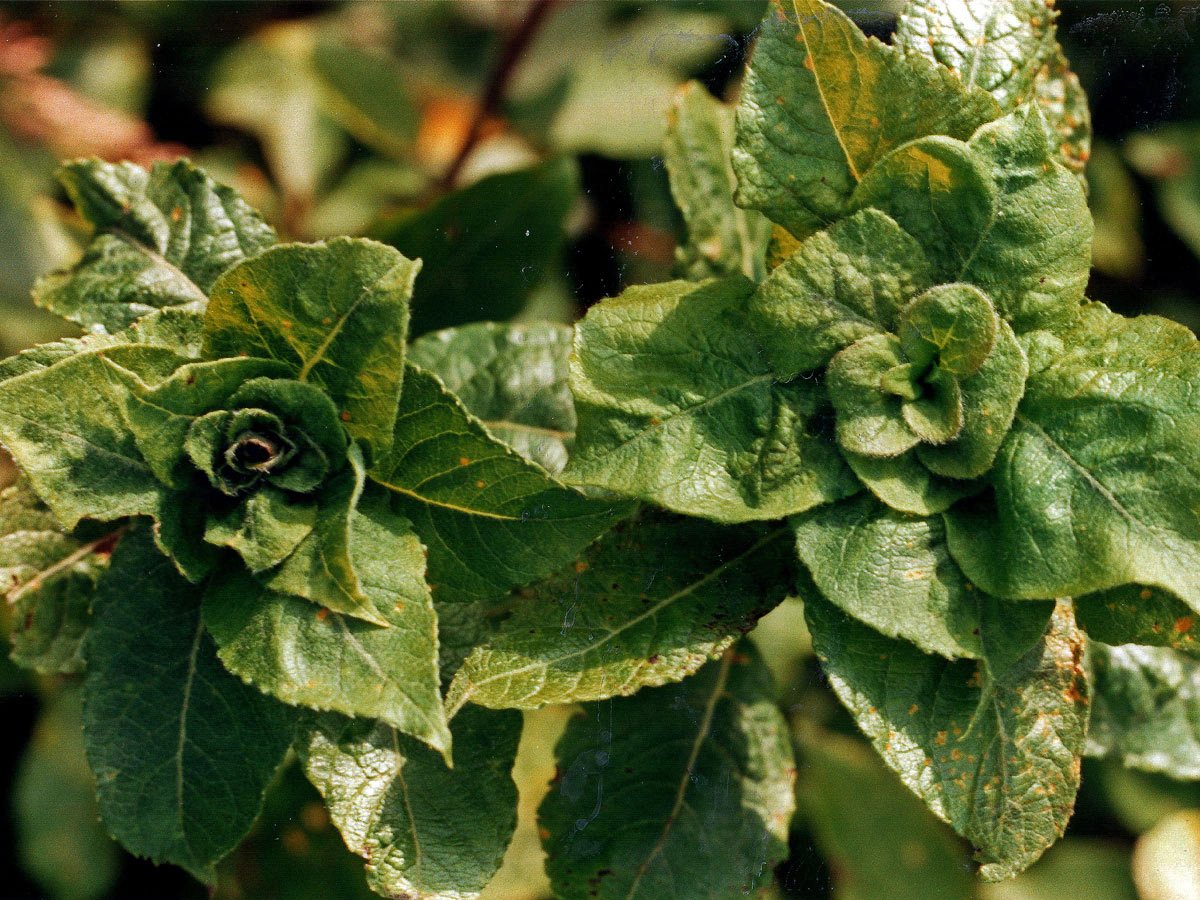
[1074,584,1200,653]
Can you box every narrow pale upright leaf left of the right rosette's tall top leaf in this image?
[662,82,770,281]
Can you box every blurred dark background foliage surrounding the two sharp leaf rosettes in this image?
[0,0,1200,900]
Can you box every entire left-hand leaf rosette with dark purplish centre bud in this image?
[0,161,631,893]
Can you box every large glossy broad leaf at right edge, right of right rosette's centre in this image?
[946,304,1200,610]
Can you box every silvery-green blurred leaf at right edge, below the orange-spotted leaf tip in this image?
[1087,642,1200,779]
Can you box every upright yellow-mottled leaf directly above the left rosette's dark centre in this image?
[204,238,421,455]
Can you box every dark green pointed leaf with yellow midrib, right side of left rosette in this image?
[368,366,631,602]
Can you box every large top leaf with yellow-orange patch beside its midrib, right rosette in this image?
[733,0,1000,238]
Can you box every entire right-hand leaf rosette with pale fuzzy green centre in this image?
[561,0,1200,878]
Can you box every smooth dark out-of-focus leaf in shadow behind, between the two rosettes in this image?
[373,158,580,335]
